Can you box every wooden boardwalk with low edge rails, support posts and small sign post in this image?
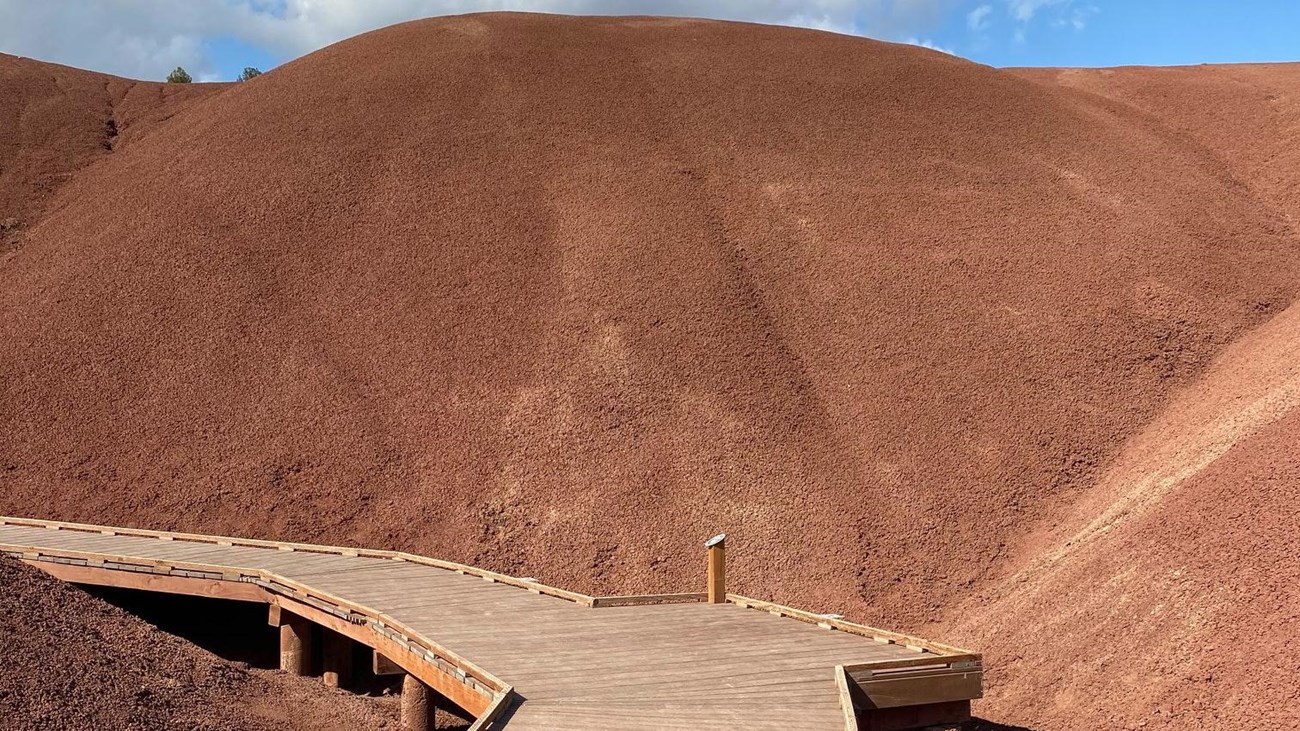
[0,518,982,731]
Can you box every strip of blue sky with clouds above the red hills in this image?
[0,0,1300,81]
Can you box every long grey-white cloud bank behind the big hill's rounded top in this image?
[0,0,954,79]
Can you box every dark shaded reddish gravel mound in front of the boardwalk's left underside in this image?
[0,559,397,731]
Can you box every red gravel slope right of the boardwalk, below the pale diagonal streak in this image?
[949,415,1300,731]
